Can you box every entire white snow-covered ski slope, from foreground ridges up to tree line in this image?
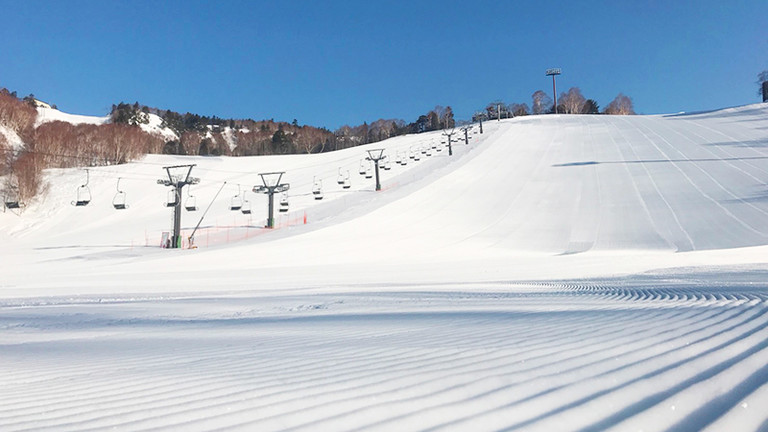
[0,104,768,431]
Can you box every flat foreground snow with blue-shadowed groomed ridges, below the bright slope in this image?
[0,276,768,431]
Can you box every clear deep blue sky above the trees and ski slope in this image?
[0,0,768,129]
